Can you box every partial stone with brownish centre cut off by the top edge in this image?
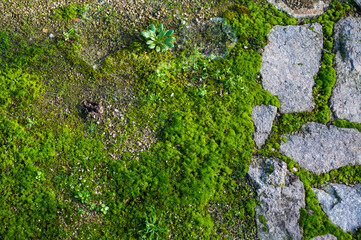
[267,0,330,18]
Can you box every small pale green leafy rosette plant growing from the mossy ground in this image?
[141,24,174,52]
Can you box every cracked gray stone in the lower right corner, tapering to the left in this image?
[313,183,361,232]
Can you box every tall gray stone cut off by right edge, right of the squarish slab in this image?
[330,17,361,123]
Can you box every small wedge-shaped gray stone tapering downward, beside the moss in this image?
[252,105,277,148]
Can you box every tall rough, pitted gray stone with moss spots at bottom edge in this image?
[248,157,305,240]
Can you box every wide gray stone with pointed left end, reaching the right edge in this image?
[280,122,361,174]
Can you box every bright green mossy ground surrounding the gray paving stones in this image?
[0,0,361,239]
